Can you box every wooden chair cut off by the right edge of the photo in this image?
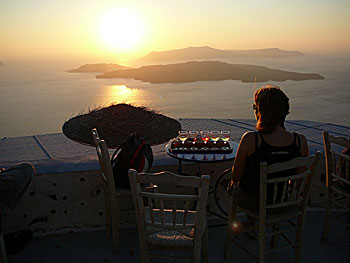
[321,132,350,242]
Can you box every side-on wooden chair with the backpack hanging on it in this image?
[91,129,135,254]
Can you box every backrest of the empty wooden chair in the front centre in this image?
[129,169,210,248]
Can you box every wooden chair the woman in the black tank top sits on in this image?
[224,152,320,262]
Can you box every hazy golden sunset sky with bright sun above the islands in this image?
[0,0,350,62]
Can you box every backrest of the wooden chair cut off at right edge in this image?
[322,132,350,188]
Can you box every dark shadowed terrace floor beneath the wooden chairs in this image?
[8,211,350,263]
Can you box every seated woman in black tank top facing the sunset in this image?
[231,85,309,209]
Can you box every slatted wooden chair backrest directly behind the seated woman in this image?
[259,152,320,214]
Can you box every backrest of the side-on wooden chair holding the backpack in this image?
[91,129,116,207]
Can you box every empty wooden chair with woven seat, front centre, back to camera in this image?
[129,169,210,263]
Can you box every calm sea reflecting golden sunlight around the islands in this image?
[0,55,350,138]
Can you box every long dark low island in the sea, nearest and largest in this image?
[96,61,324,83]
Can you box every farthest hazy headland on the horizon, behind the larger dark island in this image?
[139,46,303,61]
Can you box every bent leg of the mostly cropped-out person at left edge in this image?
[0,163,35,218]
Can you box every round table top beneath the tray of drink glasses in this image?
[165,141,238,163]
